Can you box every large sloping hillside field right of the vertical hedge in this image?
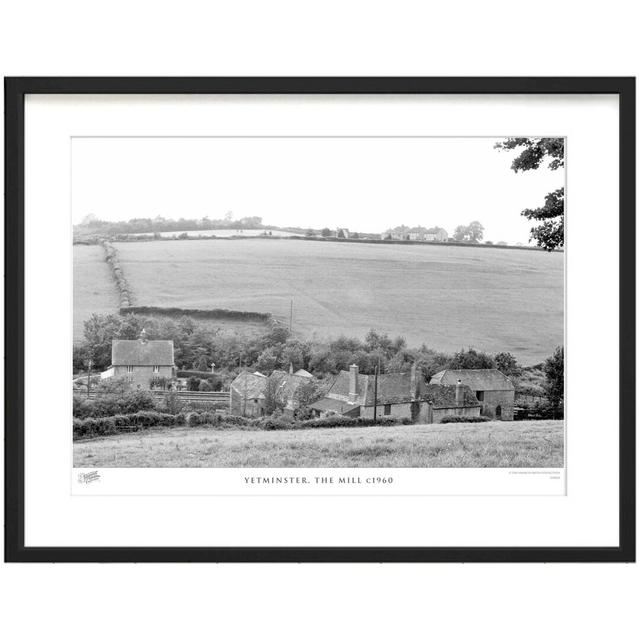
[111,239,564,364]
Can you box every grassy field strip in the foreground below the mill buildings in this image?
[74,420,564,468]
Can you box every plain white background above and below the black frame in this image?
[0,1,639,639]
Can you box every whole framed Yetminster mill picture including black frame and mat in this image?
[5,77,635,562]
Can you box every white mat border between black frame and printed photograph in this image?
[25,95,604,547]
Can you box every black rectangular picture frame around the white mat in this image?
[4,77,636,562]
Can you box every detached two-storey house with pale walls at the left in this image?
[100,329,176,388]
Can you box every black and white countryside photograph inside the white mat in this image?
[70,131,570,470]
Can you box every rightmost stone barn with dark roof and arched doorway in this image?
[430,369,515,420]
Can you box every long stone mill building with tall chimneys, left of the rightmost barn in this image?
[310,364,480,423]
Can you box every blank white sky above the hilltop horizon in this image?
[72,137,564,244]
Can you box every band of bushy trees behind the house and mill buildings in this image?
[73,313,564,416]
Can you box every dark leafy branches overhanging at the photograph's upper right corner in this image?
[495,138,564,251]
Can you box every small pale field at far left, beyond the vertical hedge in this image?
[73,244,120,341]
